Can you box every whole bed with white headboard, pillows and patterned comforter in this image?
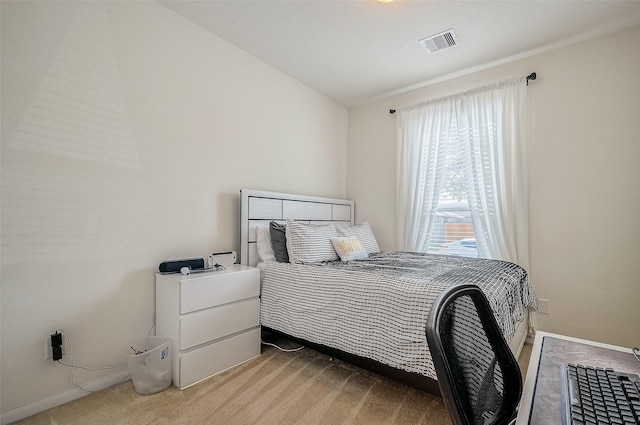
[240,189,536,393]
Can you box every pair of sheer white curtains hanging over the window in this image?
[397,78,529,268]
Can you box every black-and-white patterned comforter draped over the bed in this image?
[260,252,537,379]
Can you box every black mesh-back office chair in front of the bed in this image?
[426,285,522,425]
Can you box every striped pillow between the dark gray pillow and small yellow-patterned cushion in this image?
[286,219,339,263]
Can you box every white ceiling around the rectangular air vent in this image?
[159,0,640,106]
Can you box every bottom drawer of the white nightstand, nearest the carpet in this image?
[174,328,260,389]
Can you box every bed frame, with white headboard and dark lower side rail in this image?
[240,189,528,394]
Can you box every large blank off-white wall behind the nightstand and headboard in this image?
[0,1,347,422]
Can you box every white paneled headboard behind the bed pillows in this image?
[240,189,354,266]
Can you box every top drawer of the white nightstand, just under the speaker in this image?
[180,267,260,314]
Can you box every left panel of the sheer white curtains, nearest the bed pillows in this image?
[396,99,453,252]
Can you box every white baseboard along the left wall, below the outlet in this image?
[0,372,131,425]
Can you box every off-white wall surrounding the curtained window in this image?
[347,27,640,346]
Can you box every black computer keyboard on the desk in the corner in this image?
[562,363,640,425]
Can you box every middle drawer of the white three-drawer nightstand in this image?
[180,298,260,350]
